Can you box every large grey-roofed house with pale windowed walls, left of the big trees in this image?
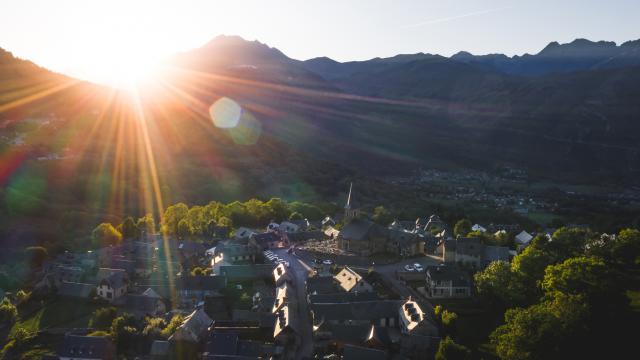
[425,265,472,298]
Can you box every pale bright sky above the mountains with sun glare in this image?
[0,0,640,82]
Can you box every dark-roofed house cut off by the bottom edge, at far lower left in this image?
[58,335,116,360]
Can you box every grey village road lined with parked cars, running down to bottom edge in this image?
[273,249,313,360]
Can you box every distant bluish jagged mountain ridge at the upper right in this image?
[451,39,640,76]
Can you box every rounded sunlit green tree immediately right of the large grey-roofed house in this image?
[474,261,524,307]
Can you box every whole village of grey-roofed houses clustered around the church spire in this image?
[0,185,556,360]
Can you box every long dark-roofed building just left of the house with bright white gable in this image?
[309,300,402,327]
